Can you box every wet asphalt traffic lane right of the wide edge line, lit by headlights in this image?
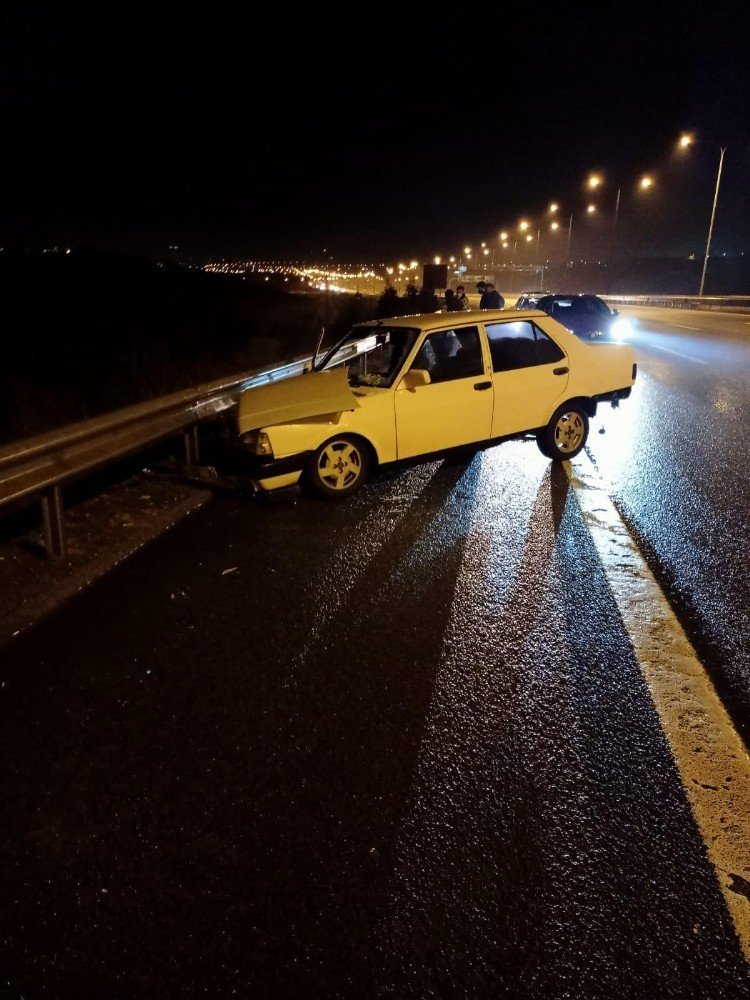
[590,309,750,745]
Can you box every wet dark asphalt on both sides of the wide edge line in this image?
[0,308,750,1000]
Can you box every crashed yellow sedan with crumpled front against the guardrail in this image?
[237,309,636,498]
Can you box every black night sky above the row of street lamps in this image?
[0,3,750,262]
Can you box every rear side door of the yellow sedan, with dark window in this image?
[485,320,569,437]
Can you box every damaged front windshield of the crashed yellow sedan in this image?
[315,326,419,389]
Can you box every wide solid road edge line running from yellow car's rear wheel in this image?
[566,454,750,961]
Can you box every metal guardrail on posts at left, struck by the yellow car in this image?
[0,355,310,557]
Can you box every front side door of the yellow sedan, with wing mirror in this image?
[395,326,492,458]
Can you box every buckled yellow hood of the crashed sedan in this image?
[237,368,359,434]
